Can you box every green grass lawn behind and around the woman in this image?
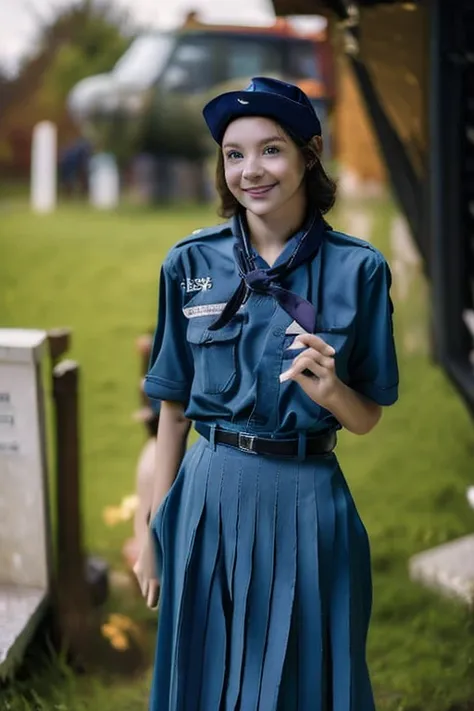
[0,196,474,711]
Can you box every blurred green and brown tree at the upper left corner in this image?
[0,0,133,178]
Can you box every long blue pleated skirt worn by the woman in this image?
[150,439,374,711]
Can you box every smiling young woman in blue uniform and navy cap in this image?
[136,78,398,711]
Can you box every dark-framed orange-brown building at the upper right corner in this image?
[273,0,474,412]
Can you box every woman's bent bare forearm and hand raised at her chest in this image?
[280,334,382,435]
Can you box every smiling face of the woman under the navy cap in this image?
[222,117,306,217]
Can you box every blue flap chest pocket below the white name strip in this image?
[186,315,242,394]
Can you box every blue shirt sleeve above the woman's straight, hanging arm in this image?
[144,258,193,410]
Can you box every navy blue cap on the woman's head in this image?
[203,77,321,145]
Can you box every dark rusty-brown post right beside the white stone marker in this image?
[53,360,91,659]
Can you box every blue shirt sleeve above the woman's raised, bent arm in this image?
[349,255,398,405]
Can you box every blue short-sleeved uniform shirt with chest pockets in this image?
[145,223,398,437]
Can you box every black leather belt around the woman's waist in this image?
[194,422,337,458]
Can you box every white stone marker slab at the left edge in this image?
[0,329,51,678]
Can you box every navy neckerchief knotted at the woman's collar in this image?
[209,211,331,333]
